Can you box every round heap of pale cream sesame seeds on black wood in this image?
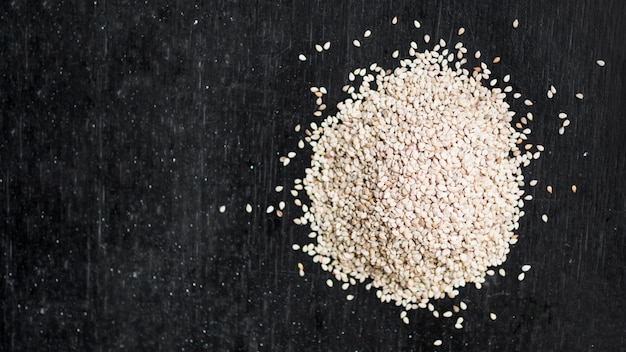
[302,48,527,308]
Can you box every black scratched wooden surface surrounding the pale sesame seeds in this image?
[0,0,626,351]
